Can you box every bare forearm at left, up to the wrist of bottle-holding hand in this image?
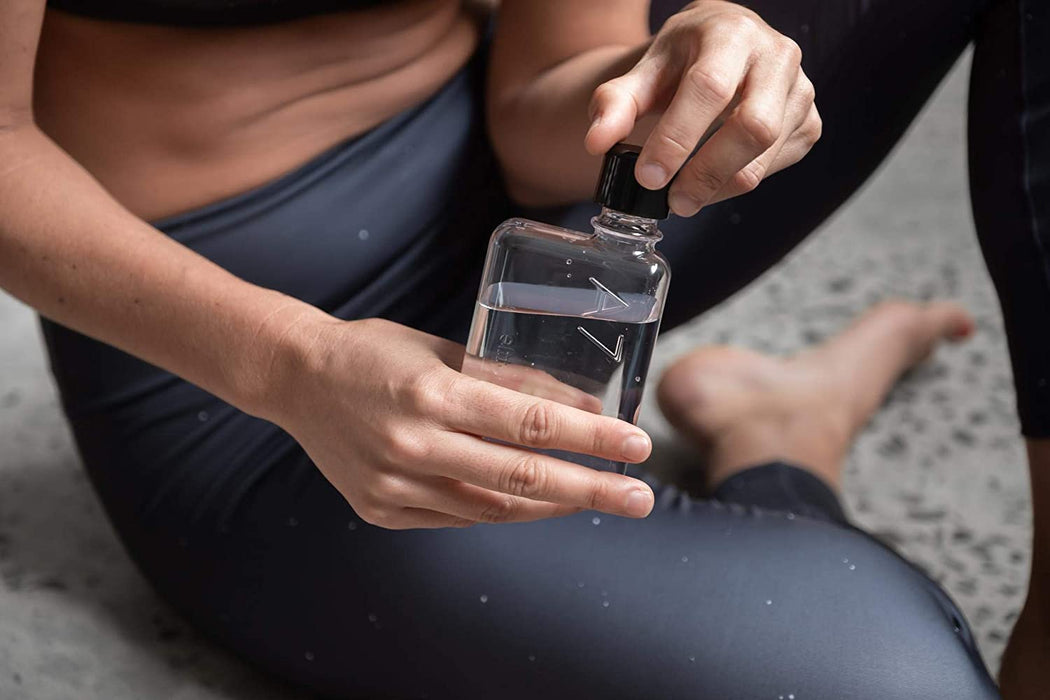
[0,124,323,415]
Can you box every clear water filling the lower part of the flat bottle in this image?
[463,277,659,471]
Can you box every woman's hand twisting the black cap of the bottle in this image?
[585,0,821,216]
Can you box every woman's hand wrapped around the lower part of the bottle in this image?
[267,319,653,529]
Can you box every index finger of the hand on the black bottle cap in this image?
[634,36,754,190]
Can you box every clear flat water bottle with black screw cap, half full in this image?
[463,144,671,472]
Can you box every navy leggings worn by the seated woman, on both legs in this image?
[37,0,1050,700]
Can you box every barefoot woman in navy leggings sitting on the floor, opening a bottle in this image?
[0,0,1050,699]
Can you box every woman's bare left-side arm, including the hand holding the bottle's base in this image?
[0,0,653,528]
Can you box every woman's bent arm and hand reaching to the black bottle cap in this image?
[488,0,820,216]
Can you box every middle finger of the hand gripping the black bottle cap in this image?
[668,41,800,216]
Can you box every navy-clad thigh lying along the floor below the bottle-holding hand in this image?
[110,430,995,700]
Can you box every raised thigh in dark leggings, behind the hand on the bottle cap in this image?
[562,0,985,328]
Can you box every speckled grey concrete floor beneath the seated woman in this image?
[0,56,1029,700]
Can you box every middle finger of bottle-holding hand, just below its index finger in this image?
[430,433,653,519]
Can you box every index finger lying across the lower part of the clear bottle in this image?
[443,378,652,463]
